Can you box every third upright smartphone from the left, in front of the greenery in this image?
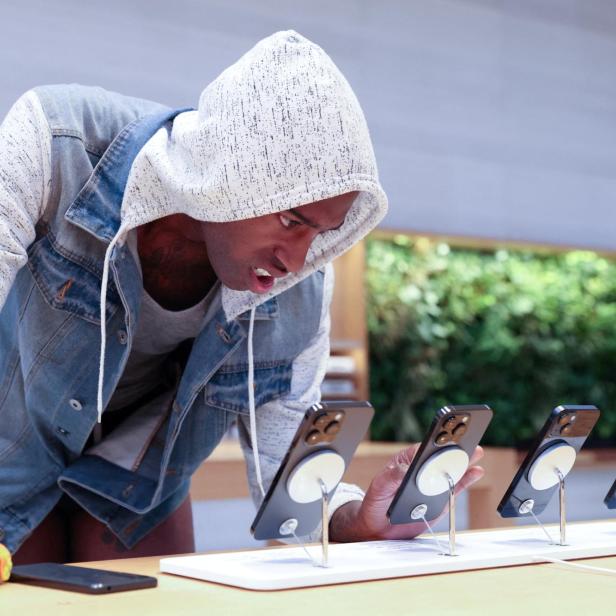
[497,405,600,518]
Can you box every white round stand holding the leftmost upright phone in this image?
[279,450,345,567]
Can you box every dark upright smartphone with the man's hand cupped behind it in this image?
[387,404,493,524]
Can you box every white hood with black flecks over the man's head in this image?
[117,31,387,320]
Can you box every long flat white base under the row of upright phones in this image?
[160,521,616,590]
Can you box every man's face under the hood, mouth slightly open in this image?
[202,192,358,293]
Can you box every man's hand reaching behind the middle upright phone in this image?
[329,445,484,541]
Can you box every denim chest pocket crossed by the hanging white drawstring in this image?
[205,360,293,414]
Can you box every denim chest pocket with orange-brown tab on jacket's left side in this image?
[28,234,120,325]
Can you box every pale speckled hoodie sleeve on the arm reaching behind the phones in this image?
[239,264,364,541]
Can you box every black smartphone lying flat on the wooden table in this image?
[10,563,158,595]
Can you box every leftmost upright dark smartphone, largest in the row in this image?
[250,401,374,539]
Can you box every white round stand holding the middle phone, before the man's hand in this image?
[411,447,469,556]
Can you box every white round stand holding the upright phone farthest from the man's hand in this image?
[518,443,577,546]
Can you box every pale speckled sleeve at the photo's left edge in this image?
[0,90,51,310]
